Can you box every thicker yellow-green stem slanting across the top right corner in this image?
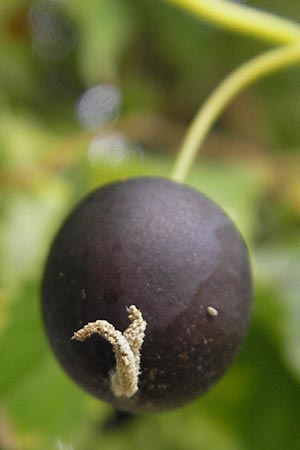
[165,0,300,44]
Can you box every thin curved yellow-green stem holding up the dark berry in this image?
[171,43,300,182]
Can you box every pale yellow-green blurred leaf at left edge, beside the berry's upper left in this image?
[0,179,69,296]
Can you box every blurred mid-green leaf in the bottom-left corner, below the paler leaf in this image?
[0,284,102,450]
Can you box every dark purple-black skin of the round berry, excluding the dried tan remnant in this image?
[42,177,252,412]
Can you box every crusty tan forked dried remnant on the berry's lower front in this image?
[71,305,147,398]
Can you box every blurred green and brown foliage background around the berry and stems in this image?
[0,0,300,450]
